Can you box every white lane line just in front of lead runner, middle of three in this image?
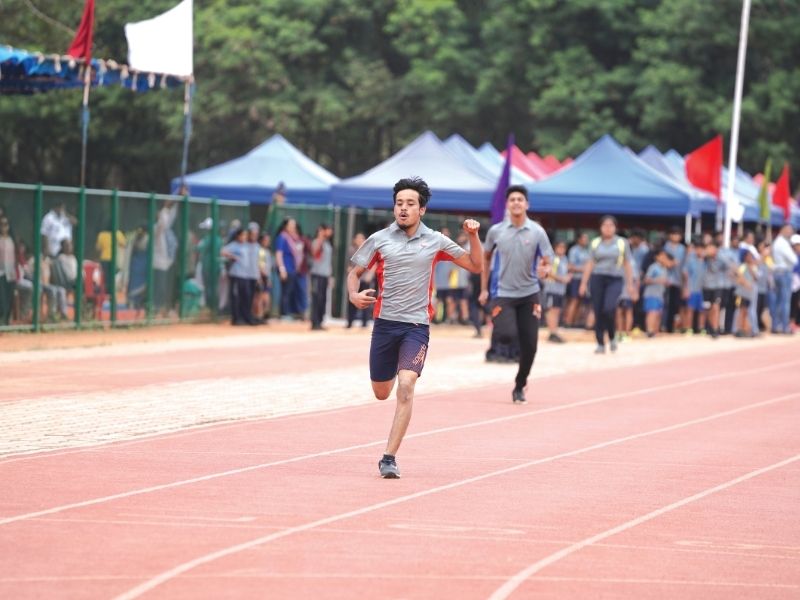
[109,392,800,600]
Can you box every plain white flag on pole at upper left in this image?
[125,0,194,77]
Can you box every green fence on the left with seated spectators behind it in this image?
[0,184,249,331]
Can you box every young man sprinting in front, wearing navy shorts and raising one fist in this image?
[347,177,483,479]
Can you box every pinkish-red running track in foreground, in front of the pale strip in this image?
[0,336,800,599]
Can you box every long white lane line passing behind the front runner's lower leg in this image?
[0,360,800,525]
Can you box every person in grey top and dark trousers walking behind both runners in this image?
[579,215,639,354]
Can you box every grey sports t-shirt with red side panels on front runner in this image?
[350,222,466,324]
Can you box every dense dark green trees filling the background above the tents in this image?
[0,0,800,190]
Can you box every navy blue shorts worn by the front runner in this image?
[369,319,430,381]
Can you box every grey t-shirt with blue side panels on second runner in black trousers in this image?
[485,219,553,298]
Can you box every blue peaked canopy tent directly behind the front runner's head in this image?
[331,131,497,212]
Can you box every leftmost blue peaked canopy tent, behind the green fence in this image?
[172,134,339,204]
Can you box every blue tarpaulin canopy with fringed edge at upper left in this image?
[0,46,186,94]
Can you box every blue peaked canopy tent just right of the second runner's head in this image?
[527,135,702,216]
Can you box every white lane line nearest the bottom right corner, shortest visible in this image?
[489,452,800,600]
